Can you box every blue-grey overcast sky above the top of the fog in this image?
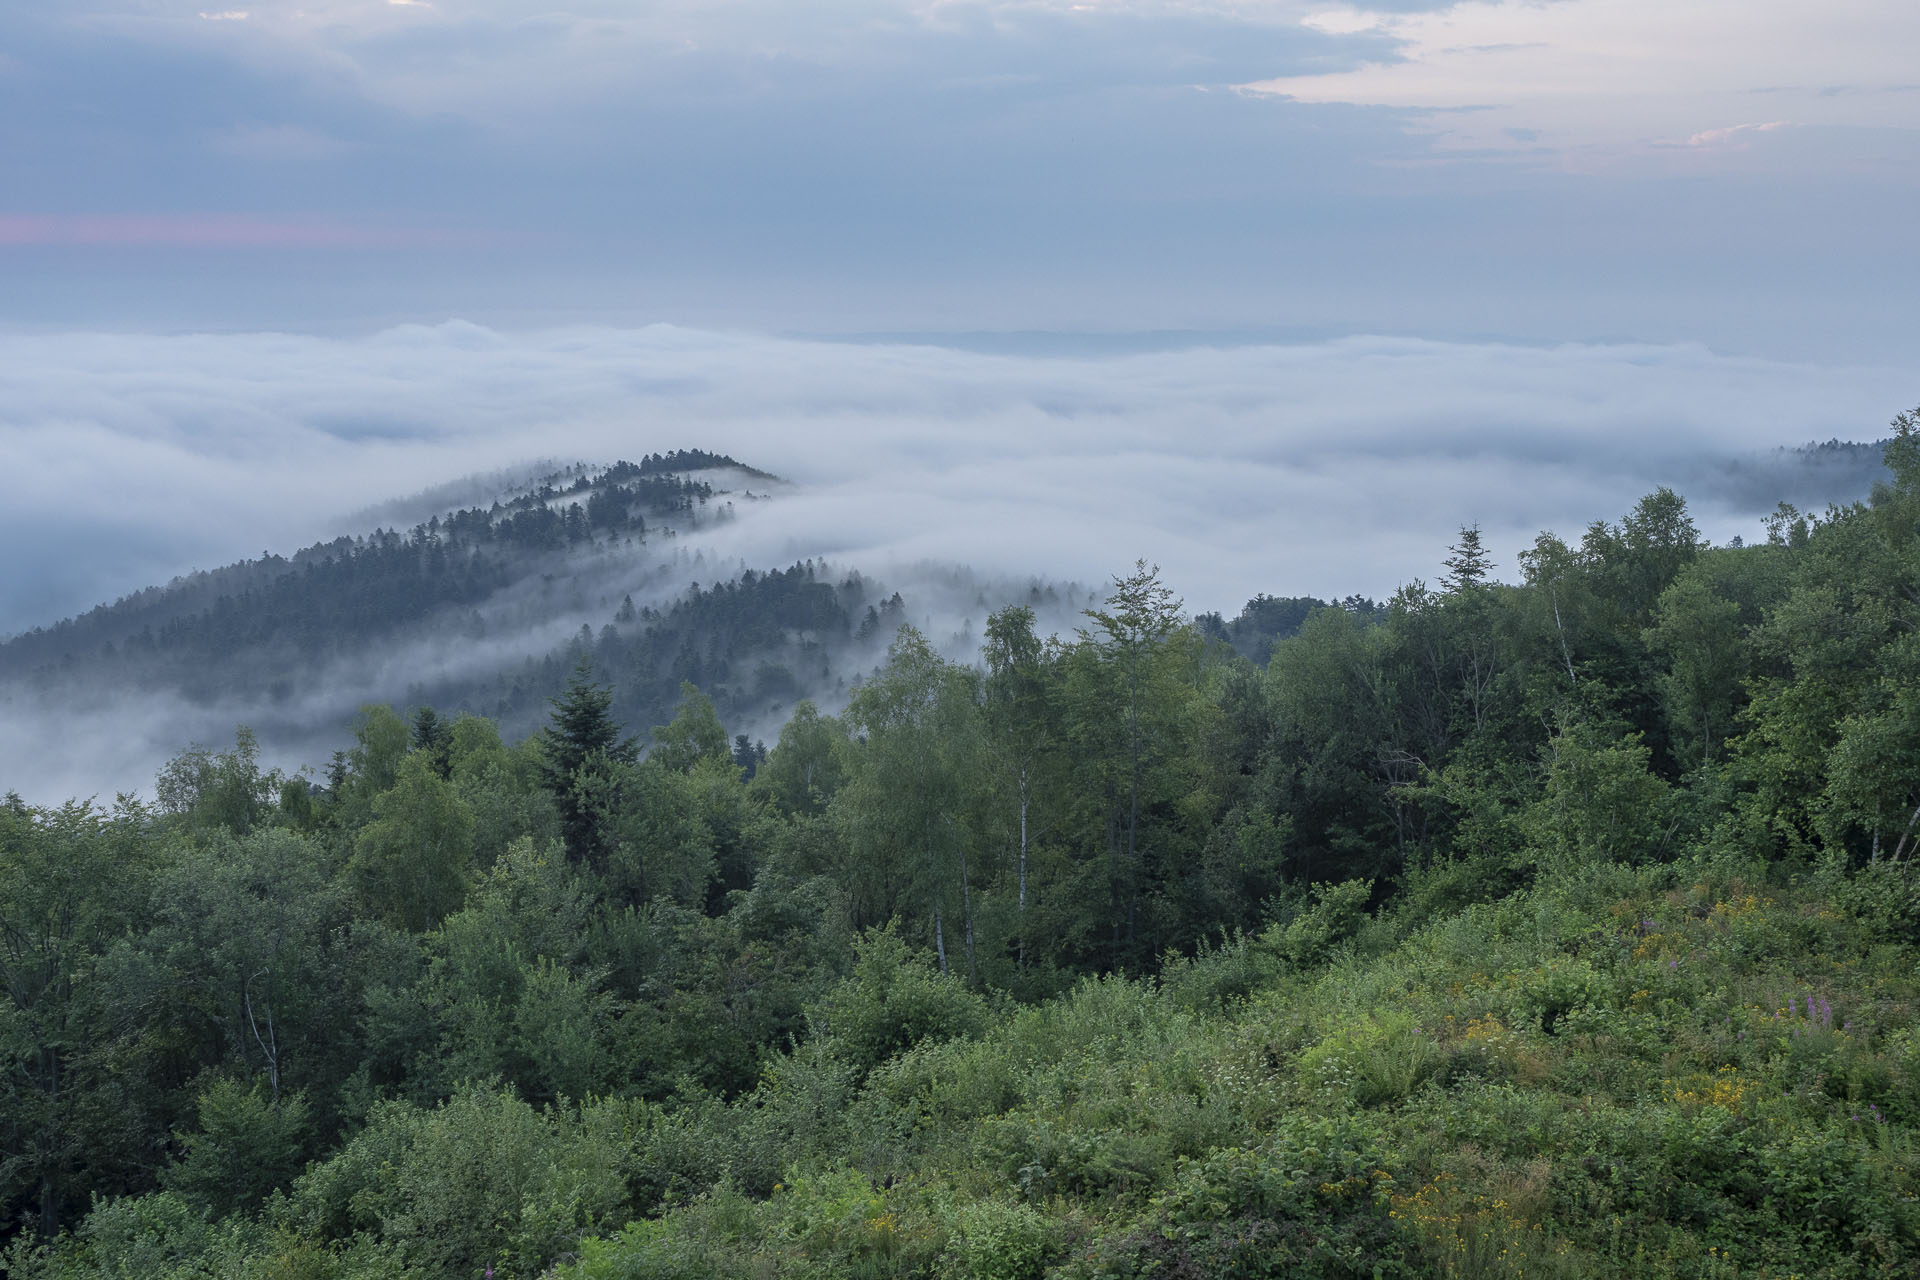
[0,0,1920,361]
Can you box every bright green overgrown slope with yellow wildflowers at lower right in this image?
[564,867,1920,1280]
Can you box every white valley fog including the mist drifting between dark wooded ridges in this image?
[0,322,1899,798]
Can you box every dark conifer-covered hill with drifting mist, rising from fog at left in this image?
[0,449,1085,791]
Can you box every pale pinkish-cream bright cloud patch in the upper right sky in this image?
[1260,0,1920,163]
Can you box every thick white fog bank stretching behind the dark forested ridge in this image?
[0,322,1914,800]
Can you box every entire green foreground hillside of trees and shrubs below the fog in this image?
[11,415,1920,1280]
